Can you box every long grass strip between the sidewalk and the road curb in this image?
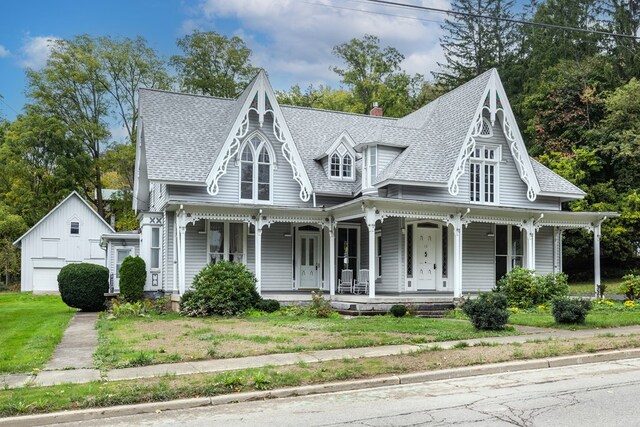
[0,336,640,417]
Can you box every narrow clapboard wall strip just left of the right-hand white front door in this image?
[376,218,403,292]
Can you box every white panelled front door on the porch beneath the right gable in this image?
[415,226,438,291]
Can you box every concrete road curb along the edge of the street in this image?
[5,348,640,427]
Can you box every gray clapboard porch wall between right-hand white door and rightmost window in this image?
[462,223,496,292]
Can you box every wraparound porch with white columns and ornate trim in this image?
[165,197,616,300]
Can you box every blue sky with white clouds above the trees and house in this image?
[0,0,449,123]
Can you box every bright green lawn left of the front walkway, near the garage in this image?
[0,292,75,373]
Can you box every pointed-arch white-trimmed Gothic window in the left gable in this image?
[240,135,273,203]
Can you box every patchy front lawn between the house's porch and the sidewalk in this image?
[95,313,516,369]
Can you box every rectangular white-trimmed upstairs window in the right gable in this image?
[469,144,500,204]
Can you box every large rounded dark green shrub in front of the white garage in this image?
[58,263,109,311]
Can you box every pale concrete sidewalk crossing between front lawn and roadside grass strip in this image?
[0,325,640,388]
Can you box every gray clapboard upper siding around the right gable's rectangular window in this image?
[387,115,561,210]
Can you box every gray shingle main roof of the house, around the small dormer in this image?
[140,70,584,199]
